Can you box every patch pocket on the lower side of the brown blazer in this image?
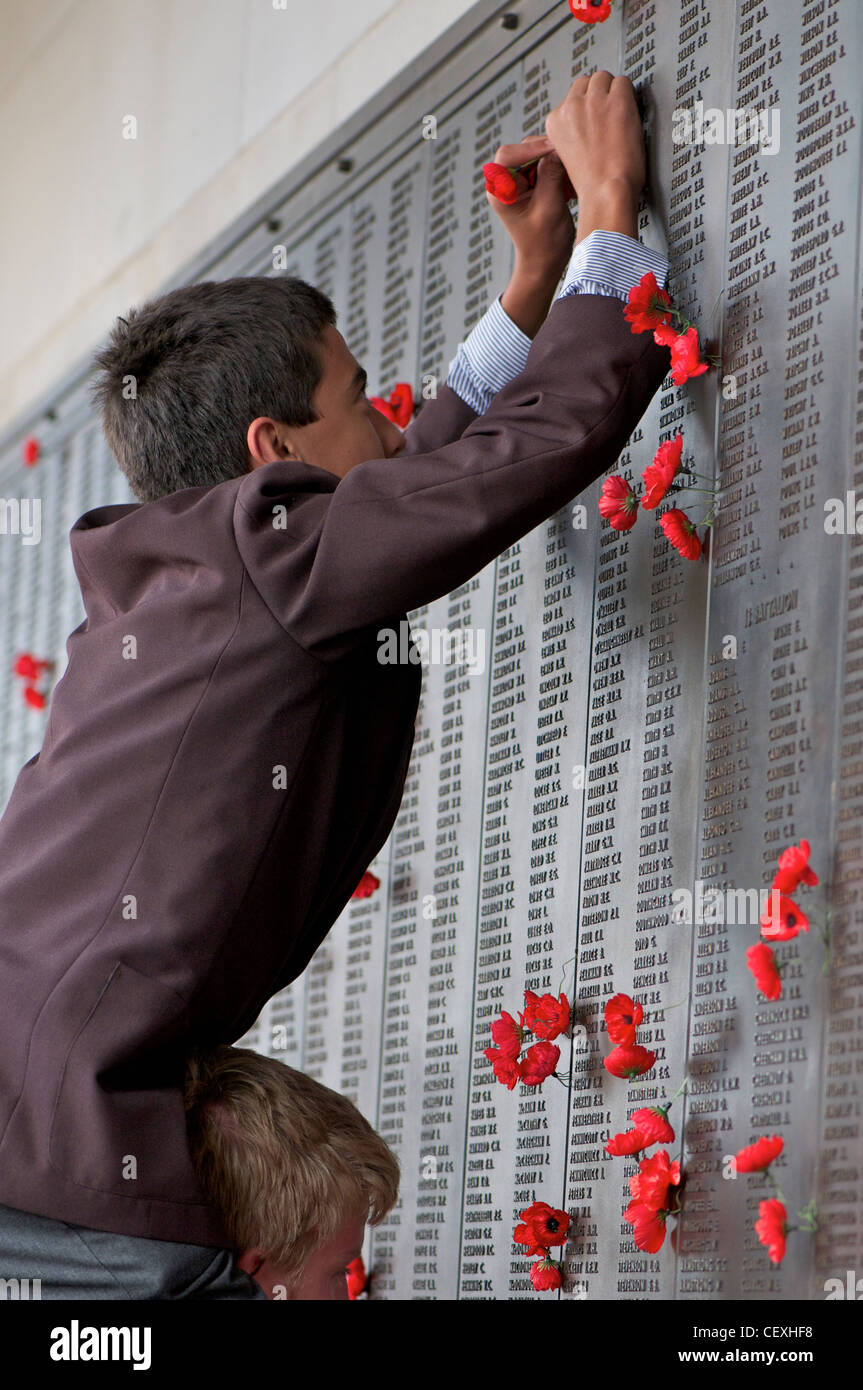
[49,960,203,1204]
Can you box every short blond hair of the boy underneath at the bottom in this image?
[185,1045,399,1284]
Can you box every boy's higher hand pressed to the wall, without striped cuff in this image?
[545,68,646,242]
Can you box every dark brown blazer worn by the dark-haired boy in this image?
[0,295,670,1245]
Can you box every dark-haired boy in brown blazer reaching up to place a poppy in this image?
[0,72,670,1298]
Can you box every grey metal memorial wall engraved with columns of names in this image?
[0,0,863,1300]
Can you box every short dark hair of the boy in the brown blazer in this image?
[92,275,336,502]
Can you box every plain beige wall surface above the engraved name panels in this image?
[0,0,471,431]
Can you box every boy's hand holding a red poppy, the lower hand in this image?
[486,135,575,286]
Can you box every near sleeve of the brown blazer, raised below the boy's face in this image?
[233,295,671,660]
